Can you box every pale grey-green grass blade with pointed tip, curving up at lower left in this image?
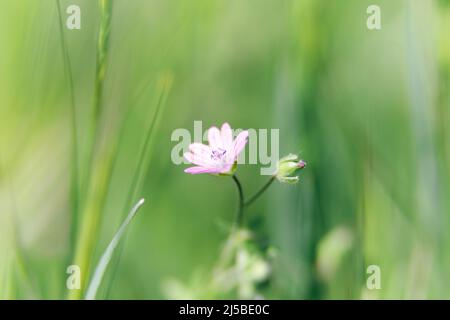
[86,199,145,300]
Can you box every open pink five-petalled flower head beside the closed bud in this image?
[184,123,248,174]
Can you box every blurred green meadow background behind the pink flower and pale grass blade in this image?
[0,0,450,299]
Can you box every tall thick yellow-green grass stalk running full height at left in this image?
[68,0,117,299]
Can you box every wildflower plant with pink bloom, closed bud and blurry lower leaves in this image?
[178,123,306,299]
